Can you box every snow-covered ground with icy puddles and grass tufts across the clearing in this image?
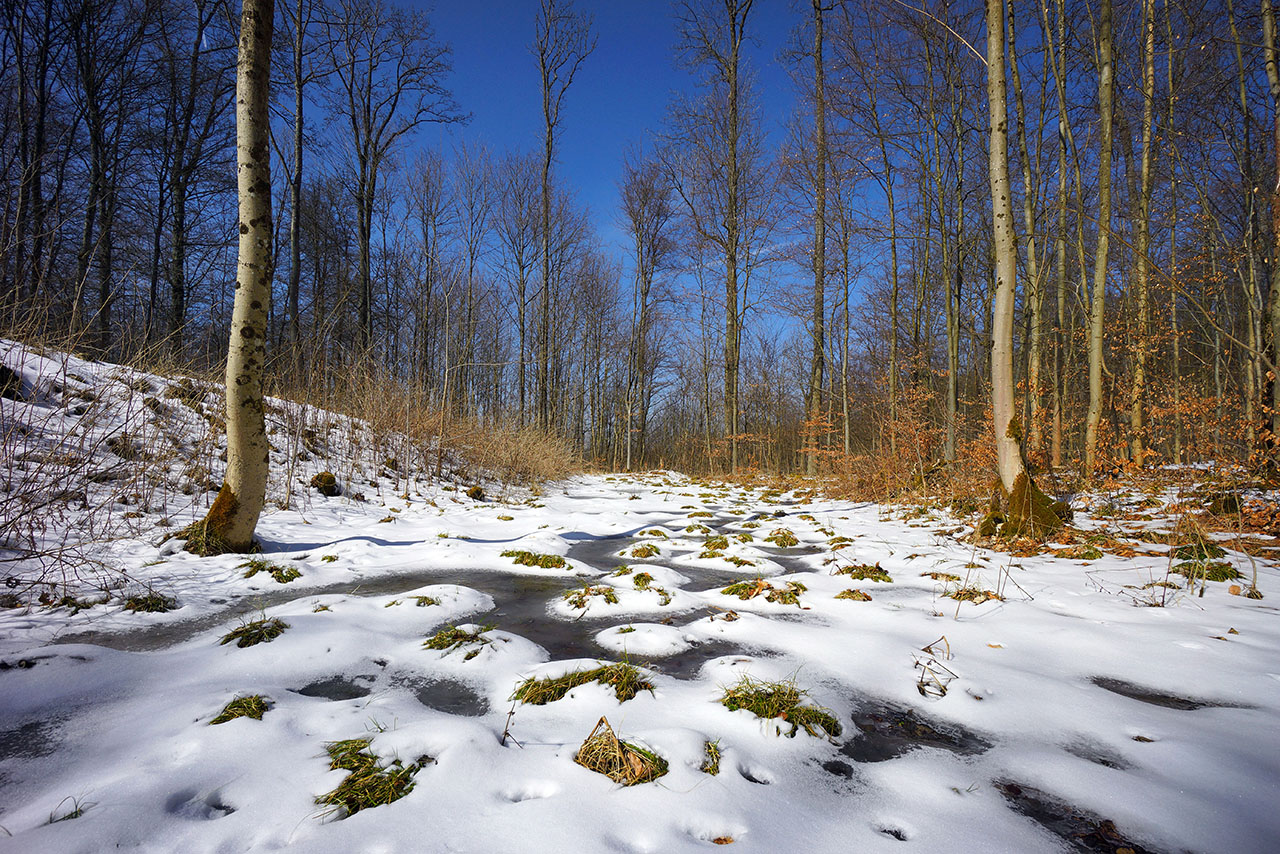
[0,343,1280,853]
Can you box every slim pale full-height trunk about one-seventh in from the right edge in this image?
[1084,0,1115,476]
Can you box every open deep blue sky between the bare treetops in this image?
[411,0,808,248]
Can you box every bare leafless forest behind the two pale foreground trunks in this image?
[0,0,1280,474]
